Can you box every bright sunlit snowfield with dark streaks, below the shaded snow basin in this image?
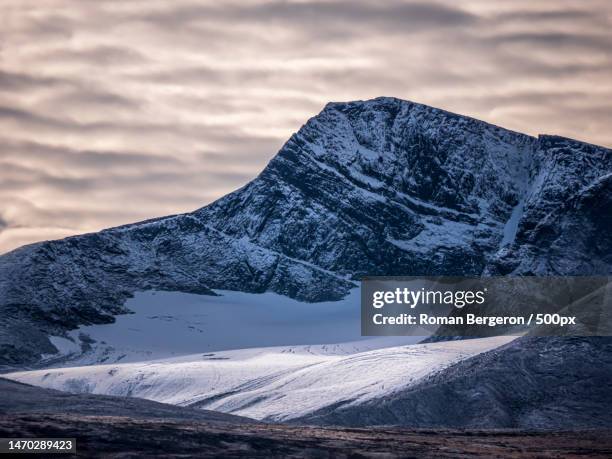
[5,337,513,421]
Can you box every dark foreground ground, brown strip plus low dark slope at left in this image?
[0,378,612,458]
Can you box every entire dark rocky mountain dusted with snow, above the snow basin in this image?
[0,98,612,364]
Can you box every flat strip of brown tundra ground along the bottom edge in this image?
[0,413,612,458]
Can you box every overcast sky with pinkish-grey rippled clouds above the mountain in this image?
[0,0,612,253]
